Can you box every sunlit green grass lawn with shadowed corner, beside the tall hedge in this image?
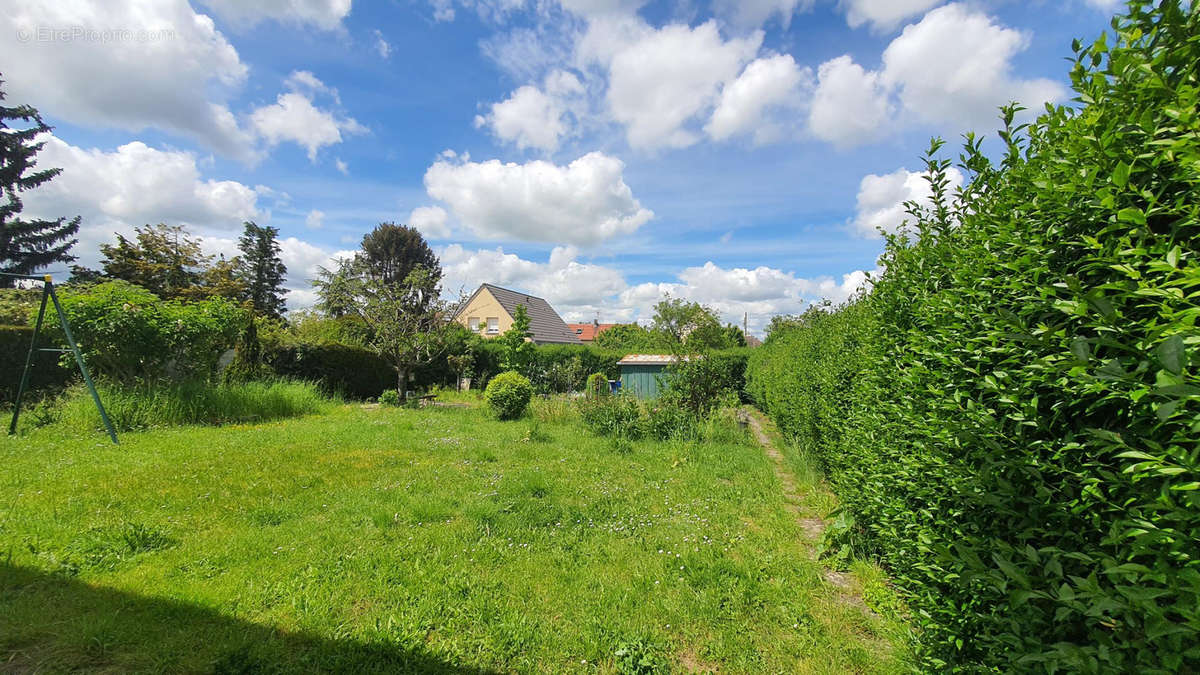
[0,396,905,673]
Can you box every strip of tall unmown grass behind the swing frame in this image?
[49,381,329,432]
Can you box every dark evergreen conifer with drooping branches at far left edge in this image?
[0,80,79,287]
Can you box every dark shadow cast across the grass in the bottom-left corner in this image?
[0,561,499,675]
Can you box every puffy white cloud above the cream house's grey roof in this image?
[425,153,654,245]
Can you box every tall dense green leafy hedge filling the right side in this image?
[748,1,1200,673]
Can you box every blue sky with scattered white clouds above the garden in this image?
[0,0,1117,330]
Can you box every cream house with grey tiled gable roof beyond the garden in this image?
[450,283,581,345]
